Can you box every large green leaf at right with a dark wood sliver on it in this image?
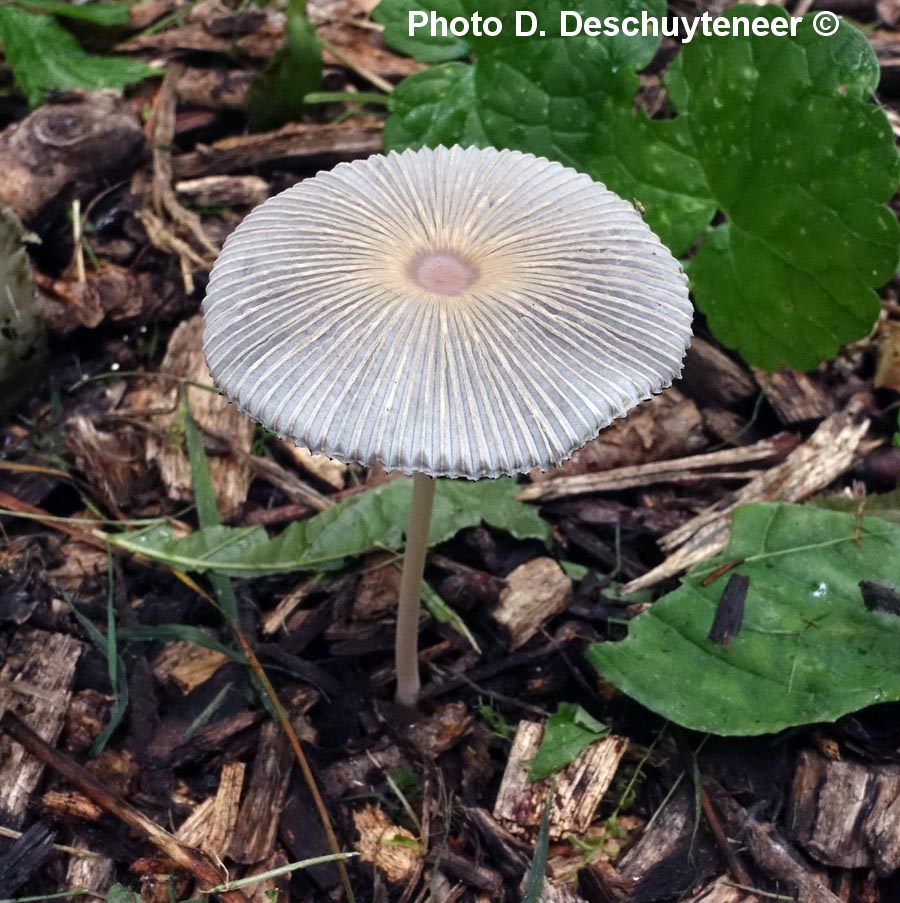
[588,504,900,735]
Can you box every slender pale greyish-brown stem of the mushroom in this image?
[396,473,436,706]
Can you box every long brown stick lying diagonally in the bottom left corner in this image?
[0,712,249,903]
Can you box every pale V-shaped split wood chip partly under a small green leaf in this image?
[494,721,628,840]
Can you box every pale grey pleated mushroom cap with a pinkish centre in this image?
[203,147,692,479]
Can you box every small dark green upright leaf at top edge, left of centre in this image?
[246,0,322,132]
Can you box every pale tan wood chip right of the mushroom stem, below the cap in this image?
[491,558,572,649]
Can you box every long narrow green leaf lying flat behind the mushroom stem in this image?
[109,479,550,577]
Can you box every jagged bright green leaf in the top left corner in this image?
[0,6,159,107]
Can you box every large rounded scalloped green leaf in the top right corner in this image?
[667,6,900,370]
